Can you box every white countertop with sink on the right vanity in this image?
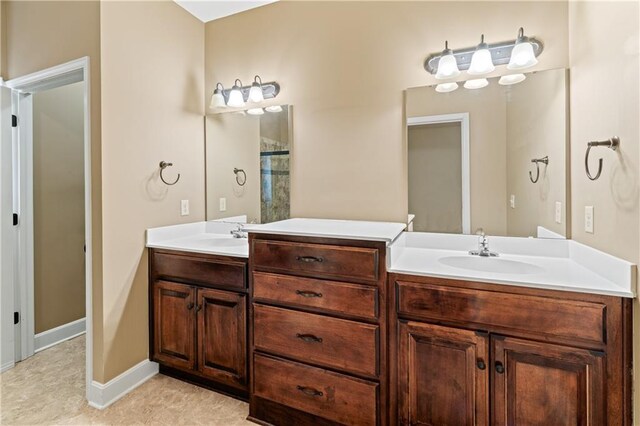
[388,232,636,297]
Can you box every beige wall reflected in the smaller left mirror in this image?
[206,114,262,221]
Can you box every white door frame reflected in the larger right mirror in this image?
[407,112,471,234]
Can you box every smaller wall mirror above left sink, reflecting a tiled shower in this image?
[206,105,292,223]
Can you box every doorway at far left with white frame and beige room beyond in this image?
[0,57,93,400]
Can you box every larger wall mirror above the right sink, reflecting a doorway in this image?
[406,69,570,238]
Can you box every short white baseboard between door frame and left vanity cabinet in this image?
[87,359,159,410]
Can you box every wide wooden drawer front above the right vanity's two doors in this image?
[397,281,606,345]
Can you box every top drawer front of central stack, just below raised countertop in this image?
[251,239,379,281]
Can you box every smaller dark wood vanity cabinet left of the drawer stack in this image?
[149,249,248,399]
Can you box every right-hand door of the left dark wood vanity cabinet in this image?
[197,289,247,388]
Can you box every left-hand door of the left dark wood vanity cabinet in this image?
[153,281,195,369]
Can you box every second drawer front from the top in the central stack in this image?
[253,272,378,319]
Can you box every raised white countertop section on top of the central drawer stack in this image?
[247,219,407,244]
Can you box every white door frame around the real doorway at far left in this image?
[5,56,93,395]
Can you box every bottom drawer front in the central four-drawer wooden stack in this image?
[253,354,378,426]
